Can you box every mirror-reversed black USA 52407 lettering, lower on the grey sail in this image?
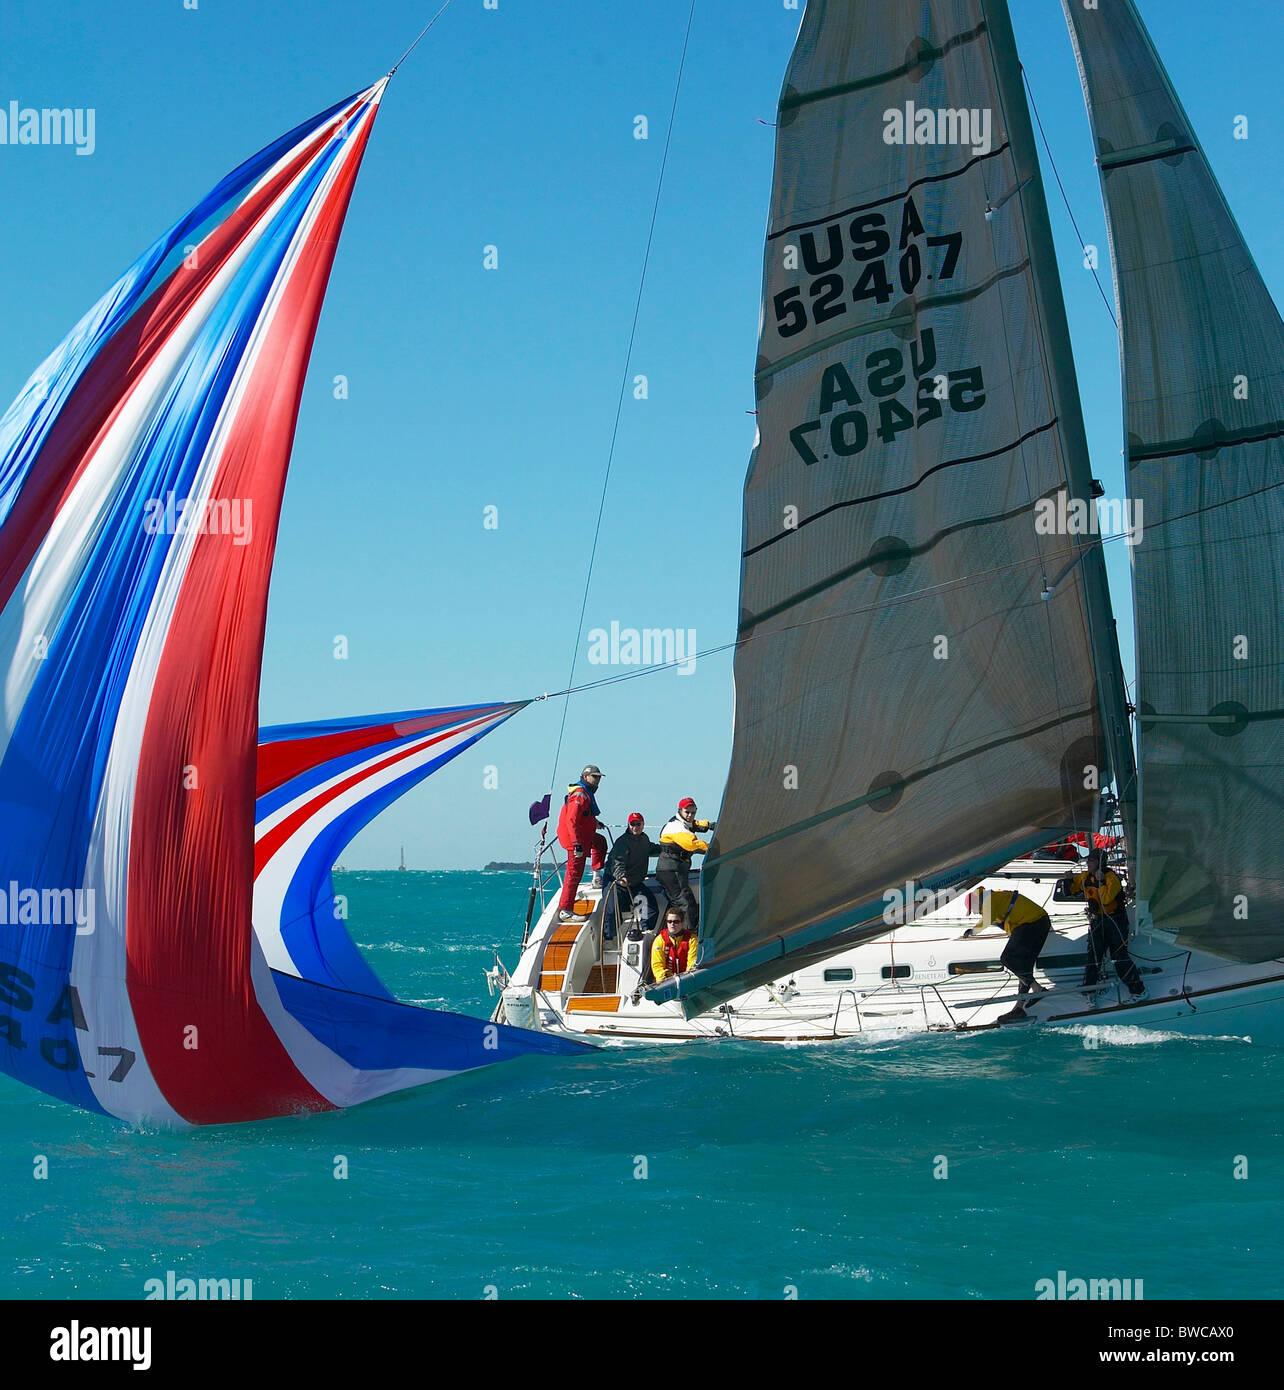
[789,328,985,466]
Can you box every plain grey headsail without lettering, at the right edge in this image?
[1064,0,1284,960]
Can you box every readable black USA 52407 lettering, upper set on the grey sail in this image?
[771,197,963,338]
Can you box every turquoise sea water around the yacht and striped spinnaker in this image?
[0,872,1284,1300]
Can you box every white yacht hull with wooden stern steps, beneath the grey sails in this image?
[495,859,1284,1044]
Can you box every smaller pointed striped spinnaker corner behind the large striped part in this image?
[254,703,525,998]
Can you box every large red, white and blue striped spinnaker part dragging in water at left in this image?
[0,82,578,1125]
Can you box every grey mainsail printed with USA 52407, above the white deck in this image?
[652,0,1130,1012]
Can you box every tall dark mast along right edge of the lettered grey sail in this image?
[981,0,1137,861]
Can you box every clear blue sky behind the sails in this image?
[0,0,1284,867]
